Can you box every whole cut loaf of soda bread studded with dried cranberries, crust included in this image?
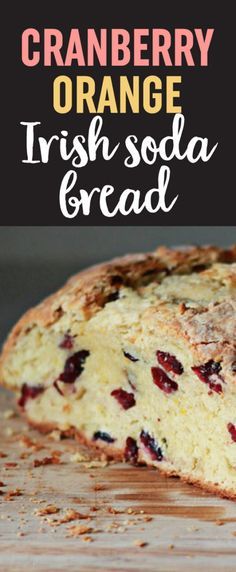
[0,247,236,498]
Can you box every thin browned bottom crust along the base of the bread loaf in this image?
[27,419,236,501]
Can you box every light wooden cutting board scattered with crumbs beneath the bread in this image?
[0,392,236,572]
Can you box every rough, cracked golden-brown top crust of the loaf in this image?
[0,246,236,381]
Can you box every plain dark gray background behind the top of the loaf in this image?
[0,226,236,342]
